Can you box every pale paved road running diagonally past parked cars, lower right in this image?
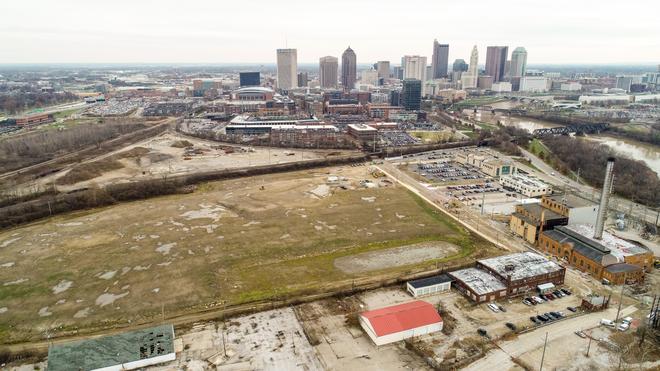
[465,306,637,371]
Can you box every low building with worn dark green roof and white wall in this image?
[48,325,176,371]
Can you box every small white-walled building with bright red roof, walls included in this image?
[360,300,442,345]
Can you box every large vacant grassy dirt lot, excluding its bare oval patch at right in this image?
[0,166,493,343]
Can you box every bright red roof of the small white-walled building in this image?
[360,300,442,336]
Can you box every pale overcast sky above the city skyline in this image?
[0,0,660,64]
